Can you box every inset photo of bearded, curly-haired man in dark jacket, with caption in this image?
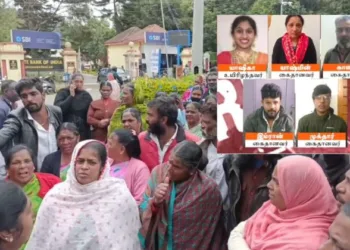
[243,79,295,148]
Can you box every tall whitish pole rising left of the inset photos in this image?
[192,0,204,74]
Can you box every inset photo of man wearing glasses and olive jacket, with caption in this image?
[295,79,348,148]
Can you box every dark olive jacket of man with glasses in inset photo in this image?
[298,108,348,133]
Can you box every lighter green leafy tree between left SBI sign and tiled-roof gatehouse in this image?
[60,18,116,67]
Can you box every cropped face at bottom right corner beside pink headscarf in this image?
[320,203,350,250]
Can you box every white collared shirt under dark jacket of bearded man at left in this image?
[26,110,57,172]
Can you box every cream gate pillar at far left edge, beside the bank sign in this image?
[0,43,25,81]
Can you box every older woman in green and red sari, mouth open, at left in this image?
[5,145,61,217]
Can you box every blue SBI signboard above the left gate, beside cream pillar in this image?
[11,30,61,49]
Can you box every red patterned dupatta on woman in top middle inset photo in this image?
[282,33,309,64]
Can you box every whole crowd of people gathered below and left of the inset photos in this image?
[0,71,350,250]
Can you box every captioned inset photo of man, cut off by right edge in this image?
[321,15,350,79]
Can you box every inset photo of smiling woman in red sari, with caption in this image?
[217,15,268,79]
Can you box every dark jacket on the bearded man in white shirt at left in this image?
[0,105,62,158]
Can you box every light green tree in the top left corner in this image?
[0,0,21,42]
